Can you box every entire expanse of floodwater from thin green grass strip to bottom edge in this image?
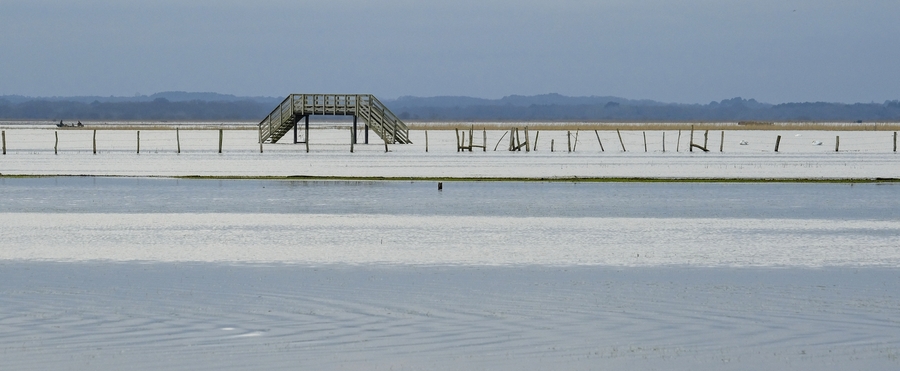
[0,177,900,370]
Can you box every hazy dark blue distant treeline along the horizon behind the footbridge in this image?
[0,92,900,122]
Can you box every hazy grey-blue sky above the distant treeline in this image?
[0,0,900,104]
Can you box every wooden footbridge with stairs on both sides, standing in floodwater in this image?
[259,94,412,144]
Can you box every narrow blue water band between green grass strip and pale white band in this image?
[0,177,900,221]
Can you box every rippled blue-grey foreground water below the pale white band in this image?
[0,262,900,370]
